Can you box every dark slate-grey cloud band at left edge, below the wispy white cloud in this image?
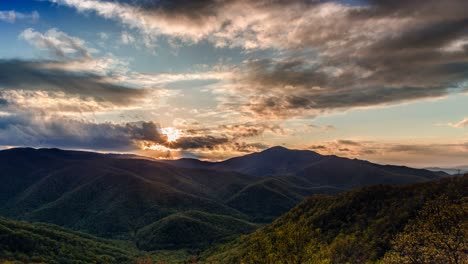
[0,60,146,105]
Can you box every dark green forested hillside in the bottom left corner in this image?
[0,217,138,263]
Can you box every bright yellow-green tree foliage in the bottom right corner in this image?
[384,197,468,264]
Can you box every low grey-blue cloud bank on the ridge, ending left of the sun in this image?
[0,114,167,151]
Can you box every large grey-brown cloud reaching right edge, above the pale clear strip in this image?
[213,54,468,118]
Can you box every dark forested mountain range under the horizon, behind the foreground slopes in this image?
[0,147,447,253]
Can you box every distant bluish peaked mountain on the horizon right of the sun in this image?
[164,146,448,186]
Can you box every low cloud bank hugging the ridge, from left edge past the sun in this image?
[0,111,268,159]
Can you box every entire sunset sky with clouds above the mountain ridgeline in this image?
[0,0,468,167]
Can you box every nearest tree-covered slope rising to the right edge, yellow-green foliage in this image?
[203,174,468,264]
